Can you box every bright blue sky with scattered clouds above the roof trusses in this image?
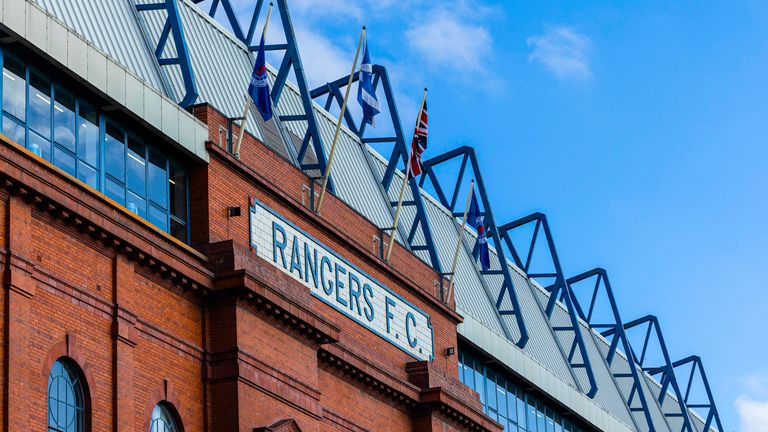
[224,0,768,432]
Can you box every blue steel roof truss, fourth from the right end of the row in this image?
[499,213,597,397]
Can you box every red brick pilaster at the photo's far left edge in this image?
[4,195,39,430]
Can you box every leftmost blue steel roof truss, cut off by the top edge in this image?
[136,0,198,108]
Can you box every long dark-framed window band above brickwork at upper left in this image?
[0,50,189,243]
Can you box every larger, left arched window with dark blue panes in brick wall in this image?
[48,359,85,432]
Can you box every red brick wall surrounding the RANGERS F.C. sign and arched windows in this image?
[0,106,501,432]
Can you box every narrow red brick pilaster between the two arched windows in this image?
[112,253,137,431]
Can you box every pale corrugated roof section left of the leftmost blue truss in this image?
[37,0,165,94]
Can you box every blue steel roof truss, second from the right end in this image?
[616,315,695,432]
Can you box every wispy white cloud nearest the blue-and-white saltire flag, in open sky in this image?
[405,11,493,74]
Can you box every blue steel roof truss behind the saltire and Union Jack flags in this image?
[310,65,442,273]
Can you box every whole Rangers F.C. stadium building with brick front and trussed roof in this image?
[0,0,722,432]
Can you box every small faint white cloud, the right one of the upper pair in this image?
[527,26,593,80]
